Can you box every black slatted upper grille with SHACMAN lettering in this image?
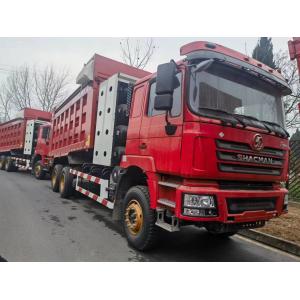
[216,140,285,176]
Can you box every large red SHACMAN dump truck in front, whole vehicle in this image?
[45,42,291,250]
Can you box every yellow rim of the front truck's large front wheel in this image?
[125,199,143,235]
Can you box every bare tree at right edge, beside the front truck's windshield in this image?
[274,51,300,128]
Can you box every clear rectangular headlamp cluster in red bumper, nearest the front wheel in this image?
[183,194,217,217]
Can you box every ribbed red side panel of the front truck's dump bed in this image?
[50,86,98,157]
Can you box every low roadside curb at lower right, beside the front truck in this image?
[239,230,300,257]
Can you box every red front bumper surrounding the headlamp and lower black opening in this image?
[175,185,288,224]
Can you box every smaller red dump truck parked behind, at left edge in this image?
[0,108,51,179]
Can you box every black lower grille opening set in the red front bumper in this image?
[226,197,276,214]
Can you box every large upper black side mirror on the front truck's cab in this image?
[156,62,180,95]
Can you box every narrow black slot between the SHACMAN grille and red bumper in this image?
[218,181,273,191]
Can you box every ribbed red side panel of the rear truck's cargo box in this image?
[0,119,26,153]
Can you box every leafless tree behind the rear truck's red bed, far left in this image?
[6,65,33,110]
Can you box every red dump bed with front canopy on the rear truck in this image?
[0,108,51,153]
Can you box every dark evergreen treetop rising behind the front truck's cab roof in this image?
[252,37,276,69]
